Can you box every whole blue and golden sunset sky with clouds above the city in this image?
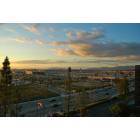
[0,23,140,69]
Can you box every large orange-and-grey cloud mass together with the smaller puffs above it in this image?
[49,30,140,61]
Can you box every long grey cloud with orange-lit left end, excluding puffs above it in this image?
[55,42,140,57]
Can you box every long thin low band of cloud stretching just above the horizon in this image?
[12,59,132,67]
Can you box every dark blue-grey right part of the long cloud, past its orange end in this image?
[90,42,140,57]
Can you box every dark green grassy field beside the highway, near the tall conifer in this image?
[0,85,58,103]
